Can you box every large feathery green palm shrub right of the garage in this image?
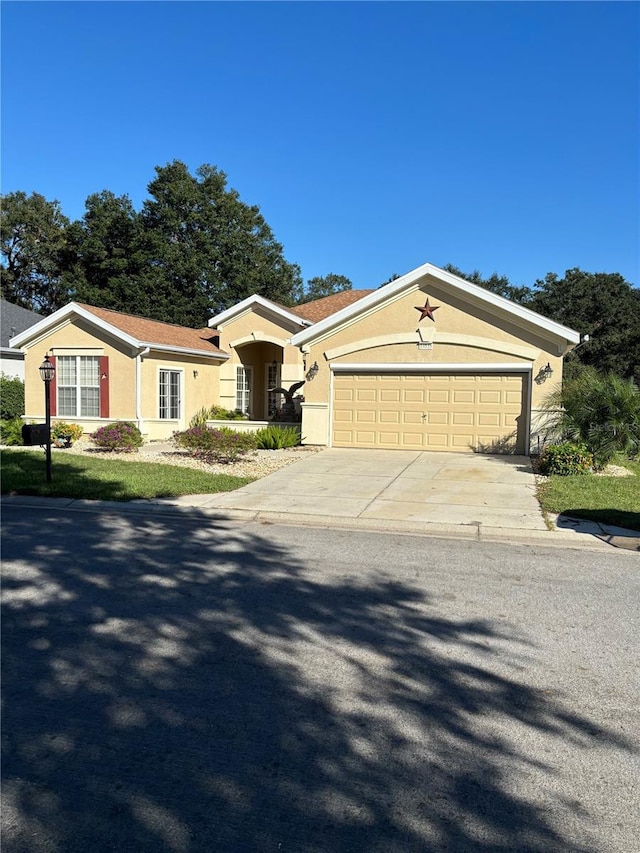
[545,367,640,469]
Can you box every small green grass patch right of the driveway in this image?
[538,459,640,530]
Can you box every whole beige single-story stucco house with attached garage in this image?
[12,264,580,453]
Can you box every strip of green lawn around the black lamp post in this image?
[2,450,253,501]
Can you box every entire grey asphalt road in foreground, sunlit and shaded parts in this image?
[2,508,640,853]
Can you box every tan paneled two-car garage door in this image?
[332,373,526,453]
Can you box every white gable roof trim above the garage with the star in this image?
[291,264,580,346]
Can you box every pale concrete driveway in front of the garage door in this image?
[201,448,546,530]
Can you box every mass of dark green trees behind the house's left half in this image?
[2,160,302,327]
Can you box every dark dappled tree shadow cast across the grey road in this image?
[3,510,627,853]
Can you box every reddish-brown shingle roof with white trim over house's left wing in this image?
[11,302,229,360]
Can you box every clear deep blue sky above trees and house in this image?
[2,0,640,288]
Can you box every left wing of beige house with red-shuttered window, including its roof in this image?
[11,302,229,440]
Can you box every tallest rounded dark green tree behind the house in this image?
[141,160,301,325]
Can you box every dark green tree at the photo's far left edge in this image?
[0,192,69,314]
